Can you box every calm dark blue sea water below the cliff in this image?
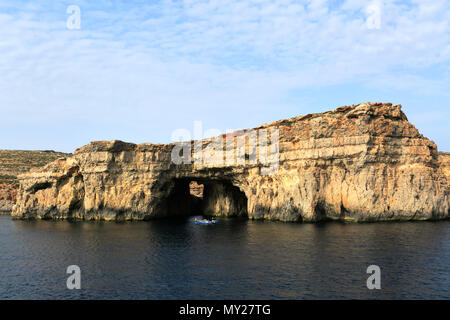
[0,217,450,299]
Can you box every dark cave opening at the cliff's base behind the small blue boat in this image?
[162,178,248,217]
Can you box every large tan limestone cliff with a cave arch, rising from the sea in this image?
[13,103,450,222]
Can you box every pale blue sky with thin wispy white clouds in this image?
[0,0,450,152]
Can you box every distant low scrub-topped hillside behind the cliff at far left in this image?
[0,150,70,214]
